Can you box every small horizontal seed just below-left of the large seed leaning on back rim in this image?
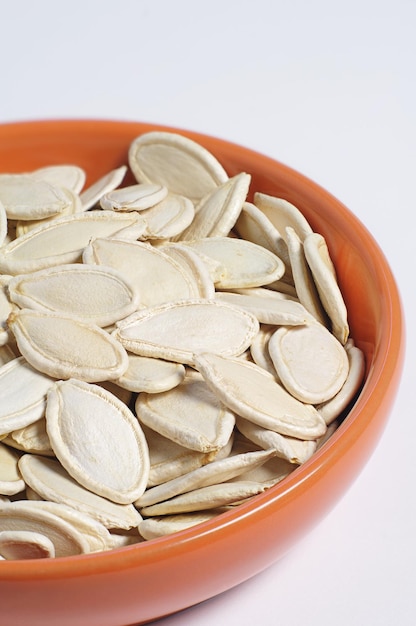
[100,183,168,211]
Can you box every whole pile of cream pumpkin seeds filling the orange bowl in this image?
[0,132,364,559]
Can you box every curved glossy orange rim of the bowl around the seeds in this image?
[0,118,405,580]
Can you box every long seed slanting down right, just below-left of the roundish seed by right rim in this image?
[195,354,326,439]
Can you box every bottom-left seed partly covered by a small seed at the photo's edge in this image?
[0,500,89,557]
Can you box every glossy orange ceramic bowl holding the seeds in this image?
[0,121,403,626]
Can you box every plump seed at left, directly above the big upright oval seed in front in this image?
[8,309,128,382]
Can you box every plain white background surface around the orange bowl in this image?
[0,0,416,626]
